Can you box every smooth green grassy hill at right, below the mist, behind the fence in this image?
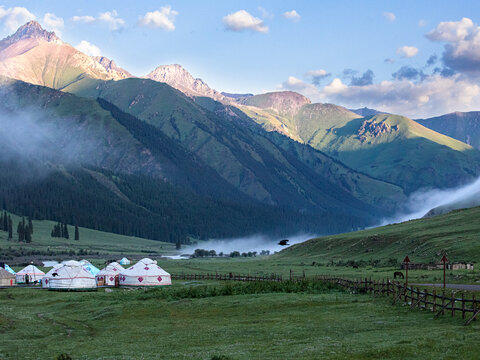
[275,207,480,263]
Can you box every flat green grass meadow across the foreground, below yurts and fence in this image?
[0,283,479,359]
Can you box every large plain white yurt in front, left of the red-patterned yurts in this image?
[47,260,97,291]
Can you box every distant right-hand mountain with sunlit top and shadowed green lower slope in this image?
[240,93,480,193]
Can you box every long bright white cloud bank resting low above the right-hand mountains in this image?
[279,74,480,118]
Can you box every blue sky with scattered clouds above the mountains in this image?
[0,0,480,118]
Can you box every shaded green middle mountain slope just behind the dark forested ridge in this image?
[67,79,401,221]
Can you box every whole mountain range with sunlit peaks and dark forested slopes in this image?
[0,21,480,241]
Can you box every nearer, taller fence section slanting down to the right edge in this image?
[315,276,480,325]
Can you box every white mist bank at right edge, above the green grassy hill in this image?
[379,178,480,225]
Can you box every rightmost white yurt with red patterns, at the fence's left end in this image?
[119,258,172,286]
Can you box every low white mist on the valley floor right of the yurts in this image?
[181,234,316,255]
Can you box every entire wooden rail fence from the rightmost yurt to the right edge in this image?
[171,271,480,325]
